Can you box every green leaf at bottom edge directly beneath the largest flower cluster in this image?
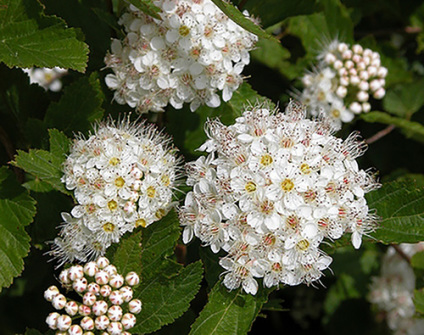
[190,282,270,335]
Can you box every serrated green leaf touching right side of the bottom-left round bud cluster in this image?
[132,262,203,334]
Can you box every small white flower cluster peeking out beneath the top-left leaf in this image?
[22,67,68,92]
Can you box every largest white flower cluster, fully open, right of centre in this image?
[180,102,379,294]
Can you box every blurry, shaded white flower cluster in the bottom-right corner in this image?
[368,242,424,335]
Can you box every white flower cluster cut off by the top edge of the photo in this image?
[105,0,257,113]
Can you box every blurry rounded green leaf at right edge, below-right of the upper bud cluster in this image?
[383,80,424,119]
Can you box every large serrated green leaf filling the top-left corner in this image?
[0,0,88,72]
